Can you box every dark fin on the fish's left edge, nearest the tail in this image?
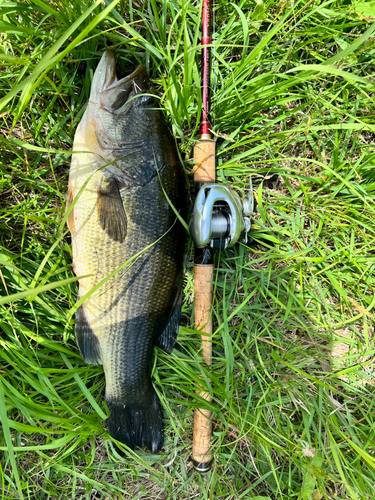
[75,305,103,365]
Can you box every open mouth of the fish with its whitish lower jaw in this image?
[90,50,146,104]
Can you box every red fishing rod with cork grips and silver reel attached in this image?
[189,0,253,473]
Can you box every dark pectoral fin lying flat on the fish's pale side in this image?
[98,177,128,243]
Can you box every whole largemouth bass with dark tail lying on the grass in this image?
[68,51,184,453]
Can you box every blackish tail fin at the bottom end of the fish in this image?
[106,392,164,453]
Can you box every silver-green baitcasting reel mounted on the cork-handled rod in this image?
[189,181,254,250]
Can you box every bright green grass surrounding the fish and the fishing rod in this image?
[0,0,375,500]
